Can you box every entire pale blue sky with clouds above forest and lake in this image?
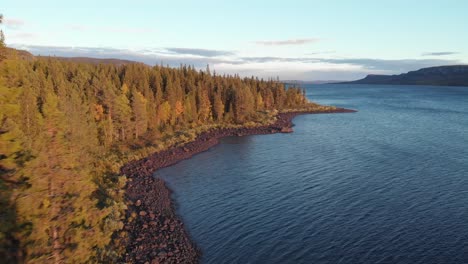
[0,0,468,81]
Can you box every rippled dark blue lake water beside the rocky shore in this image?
[156,85,468,264]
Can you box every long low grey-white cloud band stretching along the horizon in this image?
[12,45,462,80]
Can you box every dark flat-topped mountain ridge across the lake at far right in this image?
[340,65,468,86]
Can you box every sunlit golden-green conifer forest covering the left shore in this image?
[0,29,330,263]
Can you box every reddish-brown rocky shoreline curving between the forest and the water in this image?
[121,108,356,264]
